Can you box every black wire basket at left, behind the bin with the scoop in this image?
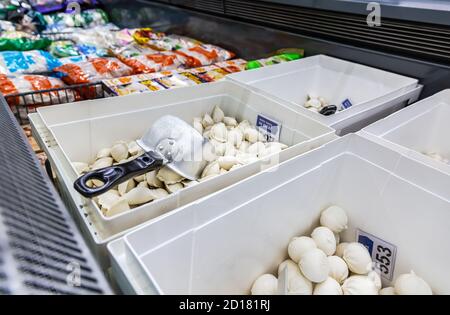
[4,82,107,125]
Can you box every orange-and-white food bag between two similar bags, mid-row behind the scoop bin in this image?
[120,51,185,74]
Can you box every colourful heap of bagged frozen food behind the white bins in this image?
[0,0,301,110]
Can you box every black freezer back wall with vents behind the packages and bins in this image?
[105,0,450,97]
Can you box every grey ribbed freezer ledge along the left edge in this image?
[0,96,111,294]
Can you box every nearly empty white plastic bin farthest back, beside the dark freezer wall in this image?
[227,55,422,135]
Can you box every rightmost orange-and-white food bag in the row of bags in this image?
[175,44,235,68]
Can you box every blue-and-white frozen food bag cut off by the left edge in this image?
[0,50,61,75]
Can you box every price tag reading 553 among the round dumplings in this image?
[356,230,397,281]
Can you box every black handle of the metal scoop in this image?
[73,152,164,198]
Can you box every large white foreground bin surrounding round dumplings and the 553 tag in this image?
[108,135,450,294]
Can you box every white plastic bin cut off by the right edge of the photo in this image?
[361,89,450,174]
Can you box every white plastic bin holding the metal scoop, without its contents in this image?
[31,82,336,262]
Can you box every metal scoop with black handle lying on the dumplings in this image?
[74,115,210,198]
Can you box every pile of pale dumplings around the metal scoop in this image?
[72,106,287,217]
